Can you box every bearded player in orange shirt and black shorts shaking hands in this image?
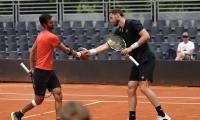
[11,14,81,120]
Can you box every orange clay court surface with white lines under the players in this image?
[0,83,200,120]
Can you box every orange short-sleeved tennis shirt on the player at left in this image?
[36,31,60,70]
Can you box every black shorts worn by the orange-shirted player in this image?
[32,68,61,96]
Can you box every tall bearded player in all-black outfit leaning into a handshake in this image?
[80,9,171,120]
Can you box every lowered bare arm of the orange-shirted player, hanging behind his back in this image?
[29,42,37,72]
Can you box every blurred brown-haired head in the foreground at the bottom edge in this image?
[61,101,90,120]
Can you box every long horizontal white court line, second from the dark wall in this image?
[0,98,200,105]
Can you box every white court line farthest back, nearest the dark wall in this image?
[0,93,200,99]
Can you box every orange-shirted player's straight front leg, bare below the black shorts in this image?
[51,88,62,119]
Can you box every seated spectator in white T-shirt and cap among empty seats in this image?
[175,32,195,61]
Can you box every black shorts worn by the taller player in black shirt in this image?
[129,57,155,82]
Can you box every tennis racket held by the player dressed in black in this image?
[106,34,139,66]
